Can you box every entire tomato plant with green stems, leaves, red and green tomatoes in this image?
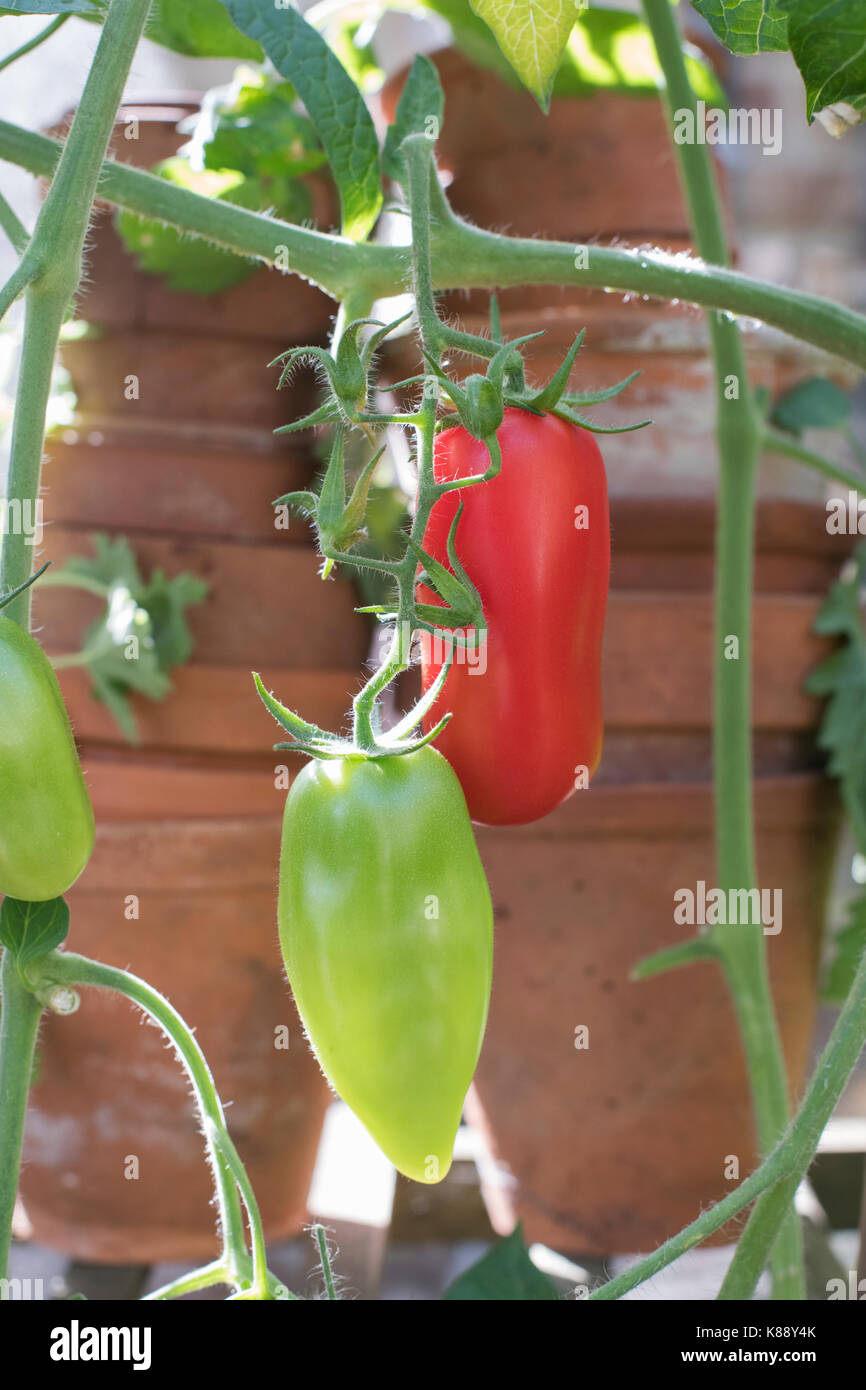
[0,0,866,1326]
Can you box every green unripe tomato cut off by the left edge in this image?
[0,617,93,902]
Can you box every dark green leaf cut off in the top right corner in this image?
[780,0,866,121]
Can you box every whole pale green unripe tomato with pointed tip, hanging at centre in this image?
[279,746,493,1183]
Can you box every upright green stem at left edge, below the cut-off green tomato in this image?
[0,951,42,1279]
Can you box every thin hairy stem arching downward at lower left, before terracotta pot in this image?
[28,951,257,1282]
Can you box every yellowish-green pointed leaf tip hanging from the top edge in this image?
[470,0,578,110]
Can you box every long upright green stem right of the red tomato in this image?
[642,0,805,1298]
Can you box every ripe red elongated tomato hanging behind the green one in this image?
[420,407,610,826]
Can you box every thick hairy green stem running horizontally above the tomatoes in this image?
[0,121,866,368]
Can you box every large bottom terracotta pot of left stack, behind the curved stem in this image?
[21,815,329,1264]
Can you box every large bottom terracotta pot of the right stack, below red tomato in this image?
[473,777,835,1255]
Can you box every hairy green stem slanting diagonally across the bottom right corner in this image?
[589,934,866,1300]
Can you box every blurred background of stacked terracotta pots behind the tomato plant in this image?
[0,6,866,1300]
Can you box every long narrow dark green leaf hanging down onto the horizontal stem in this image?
[219,0,382,240]
